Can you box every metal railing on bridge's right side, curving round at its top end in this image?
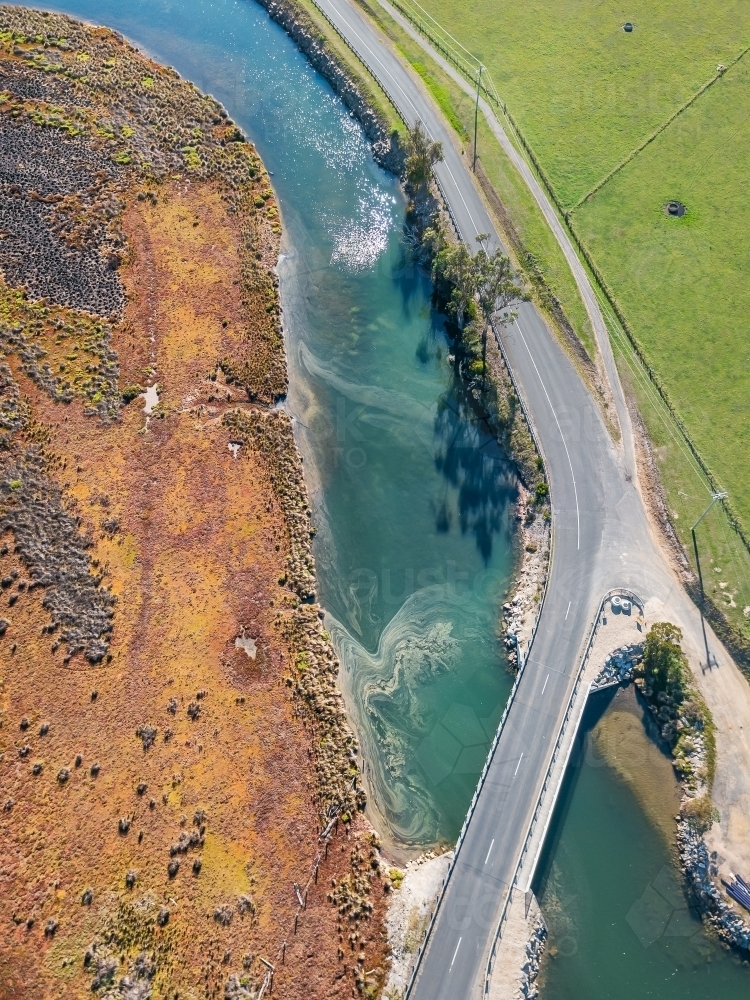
[484,587,643,994]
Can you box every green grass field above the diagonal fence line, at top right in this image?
[408,0,750,207]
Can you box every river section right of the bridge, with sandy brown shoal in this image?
[534,687,750,1000]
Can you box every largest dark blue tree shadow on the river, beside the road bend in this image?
[434,378,516,565]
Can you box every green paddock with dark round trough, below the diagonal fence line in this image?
[573,55,750,525]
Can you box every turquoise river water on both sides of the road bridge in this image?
[33,0,750,1000]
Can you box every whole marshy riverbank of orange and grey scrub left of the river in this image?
[0,7,387,998]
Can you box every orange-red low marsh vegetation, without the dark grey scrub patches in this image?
[0,181,383,1000]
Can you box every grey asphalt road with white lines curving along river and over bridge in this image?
[302,0,692,1000]
